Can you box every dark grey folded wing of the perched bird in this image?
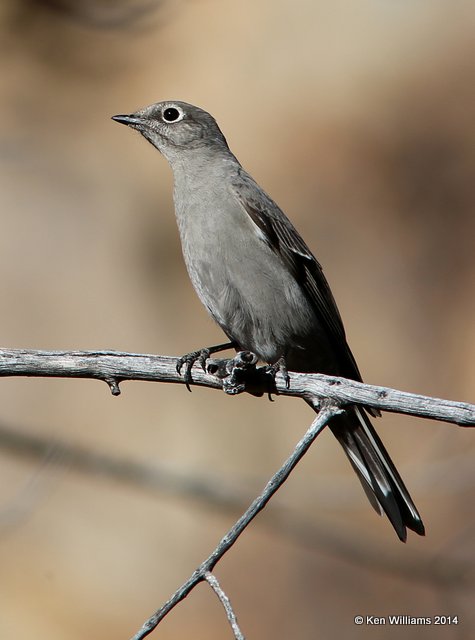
[232,169,361,380]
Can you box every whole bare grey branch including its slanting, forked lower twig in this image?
[0,349,475,640]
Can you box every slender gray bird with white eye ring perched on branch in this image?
[113,101,424,541]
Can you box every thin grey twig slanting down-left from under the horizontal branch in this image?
[128,405,342,640]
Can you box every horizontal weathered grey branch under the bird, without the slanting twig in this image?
[0,349,475,426]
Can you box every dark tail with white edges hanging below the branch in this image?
[329,407,425,542]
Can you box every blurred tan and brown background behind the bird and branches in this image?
[0,0,475,640]
